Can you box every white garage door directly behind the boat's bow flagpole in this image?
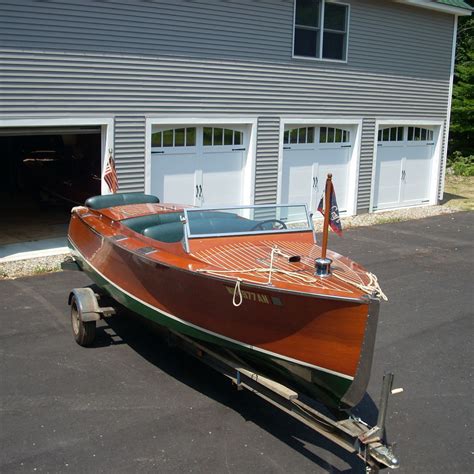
[280,127,354,213]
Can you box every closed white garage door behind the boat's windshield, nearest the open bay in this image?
[151,126,247,206]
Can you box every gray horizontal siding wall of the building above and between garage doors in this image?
[0,0,454,210]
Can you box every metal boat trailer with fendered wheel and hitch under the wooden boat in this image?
[68,288,402,474]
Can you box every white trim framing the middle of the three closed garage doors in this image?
[277,117,362,216]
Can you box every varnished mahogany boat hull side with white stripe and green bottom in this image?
[69,218,378,408]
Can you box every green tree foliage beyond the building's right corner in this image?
[449,0,474,157]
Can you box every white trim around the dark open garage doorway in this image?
[0,116,114,194]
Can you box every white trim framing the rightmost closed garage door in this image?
[369,118,444,212]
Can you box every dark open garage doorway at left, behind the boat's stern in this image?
[0,125,104,259]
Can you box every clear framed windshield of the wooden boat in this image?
[184,204,313,238]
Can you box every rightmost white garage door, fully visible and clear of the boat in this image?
[373,126,434,210]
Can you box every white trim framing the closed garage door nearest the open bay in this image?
[145,115,258,205]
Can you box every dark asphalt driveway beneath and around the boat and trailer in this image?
[0,213,474,473]
